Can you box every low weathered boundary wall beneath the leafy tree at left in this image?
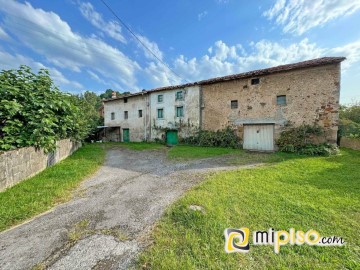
[0,139,81,191]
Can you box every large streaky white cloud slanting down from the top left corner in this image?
[0,0,141,90]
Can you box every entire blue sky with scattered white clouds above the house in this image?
[0,0,360,104]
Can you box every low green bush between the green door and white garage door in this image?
[181,127,242,148]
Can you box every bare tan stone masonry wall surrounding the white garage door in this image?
[201,64,340,143]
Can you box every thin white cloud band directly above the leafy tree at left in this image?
[0,48,83,89]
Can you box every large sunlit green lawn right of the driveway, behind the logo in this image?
[138,149,360,269]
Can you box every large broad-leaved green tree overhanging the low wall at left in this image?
[0,65,89,151]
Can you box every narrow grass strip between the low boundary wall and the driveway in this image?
[0,144,105,231]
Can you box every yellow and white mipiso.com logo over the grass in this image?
[224,228,345,253]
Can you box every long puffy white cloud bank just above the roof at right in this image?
[169,38,360,81]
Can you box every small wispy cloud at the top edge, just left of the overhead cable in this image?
[79,2,126,43]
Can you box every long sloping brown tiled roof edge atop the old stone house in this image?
[104,57,346,102]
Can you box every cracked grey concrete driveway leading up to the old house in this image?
[0,148,248,270]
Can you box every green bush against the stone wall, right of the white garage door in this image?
[276,125,338,156]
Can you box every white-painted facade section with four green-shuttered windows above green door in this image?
[150,86,200,140]
